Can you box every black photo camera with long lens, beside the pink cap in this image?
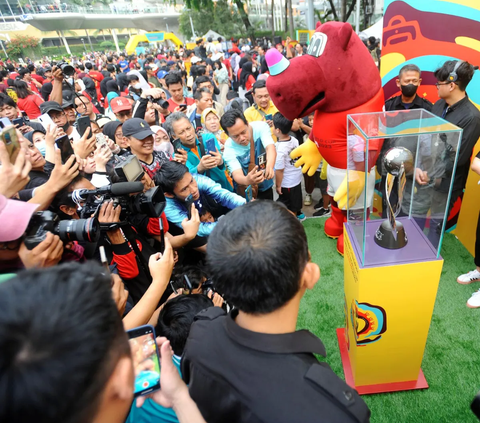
[24,210,100,250]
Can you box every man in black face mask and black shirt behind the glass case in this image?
[385,65,433,112]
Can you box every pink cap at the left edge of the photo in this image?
[0,195,38,242]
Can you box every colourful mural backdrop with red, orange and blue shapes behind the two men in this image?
[380,0,480,232]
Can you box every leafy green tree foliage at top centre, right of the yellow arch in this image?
[178,0,245,39]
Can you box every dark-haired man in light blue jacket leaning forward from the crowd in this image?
[155,161,245,237]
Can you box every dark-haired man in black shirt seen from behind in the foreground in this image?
[182,201,370,423]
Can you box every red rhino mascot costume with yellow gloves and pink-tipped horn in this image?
[266,22,384,254]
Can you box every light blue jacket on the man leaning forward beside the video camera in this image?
[165,173,245,237]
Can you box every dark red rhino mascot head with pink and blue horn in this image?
[265,22,381,120]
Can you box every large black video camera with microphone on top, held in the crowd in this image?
[69,182,166,221]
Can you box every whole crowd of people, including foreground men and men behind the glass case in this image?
[0,30,480,423]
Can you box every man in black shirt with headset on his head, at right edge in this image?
[430,60,480,208]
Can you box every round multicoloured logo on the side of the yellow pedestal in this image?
[350,300,387,346]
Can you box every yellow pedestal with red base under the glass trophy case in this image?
[339,228,443,393]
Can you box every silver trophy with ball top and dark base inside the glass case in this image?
[374,147,413,250]
